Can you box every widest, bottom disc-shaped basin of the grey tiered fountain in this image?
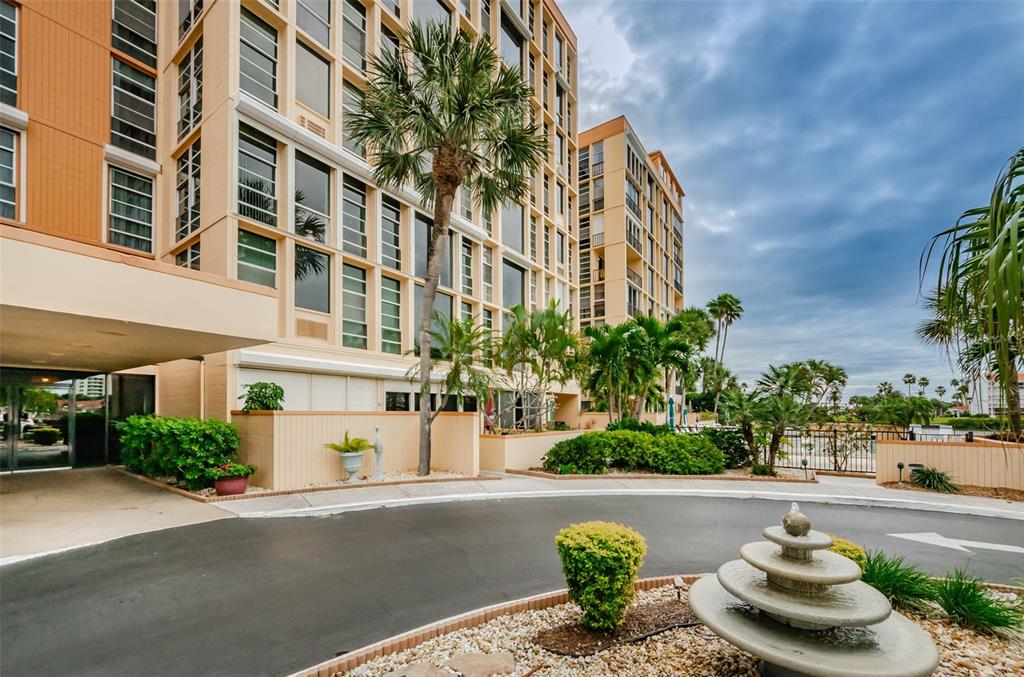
[689,576,939,677]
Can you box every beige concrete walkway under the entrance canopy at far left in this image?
[0,468,232,565]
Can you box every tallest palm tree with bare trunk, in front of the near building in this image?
[346,22,548,475]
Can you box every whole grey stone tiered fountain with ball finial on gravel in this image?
[689,503,939,677]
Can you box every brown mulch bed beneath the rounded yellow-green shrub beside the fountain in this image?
[534,599,700,658]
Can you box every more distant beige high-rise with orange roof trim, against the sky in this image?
[579,116,685,327]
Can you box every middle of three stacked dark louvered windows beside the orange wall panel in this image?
[111,58,157,160]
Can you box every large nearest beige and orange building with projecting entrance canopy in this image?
[0,0,579,469]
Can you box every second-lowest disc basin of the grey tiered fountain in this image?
[718,559,892,629]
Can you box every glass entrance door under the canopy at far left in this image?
[0,381,75,470]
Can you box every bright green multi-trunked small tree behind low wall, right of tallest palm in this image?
[495,300,580,428]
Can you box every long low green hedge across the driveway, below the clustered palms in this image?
[542,430,725,475]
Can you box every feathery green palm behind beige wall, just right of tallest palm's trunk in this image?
[406,311,492,423]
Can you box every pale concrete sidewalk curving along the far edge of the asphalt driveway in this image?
[218,474,1024,520]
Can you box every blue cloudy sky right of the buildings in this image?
[559,0,1024,396]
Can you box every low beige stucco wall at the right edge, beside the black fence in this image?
[876,441,1024,490]
